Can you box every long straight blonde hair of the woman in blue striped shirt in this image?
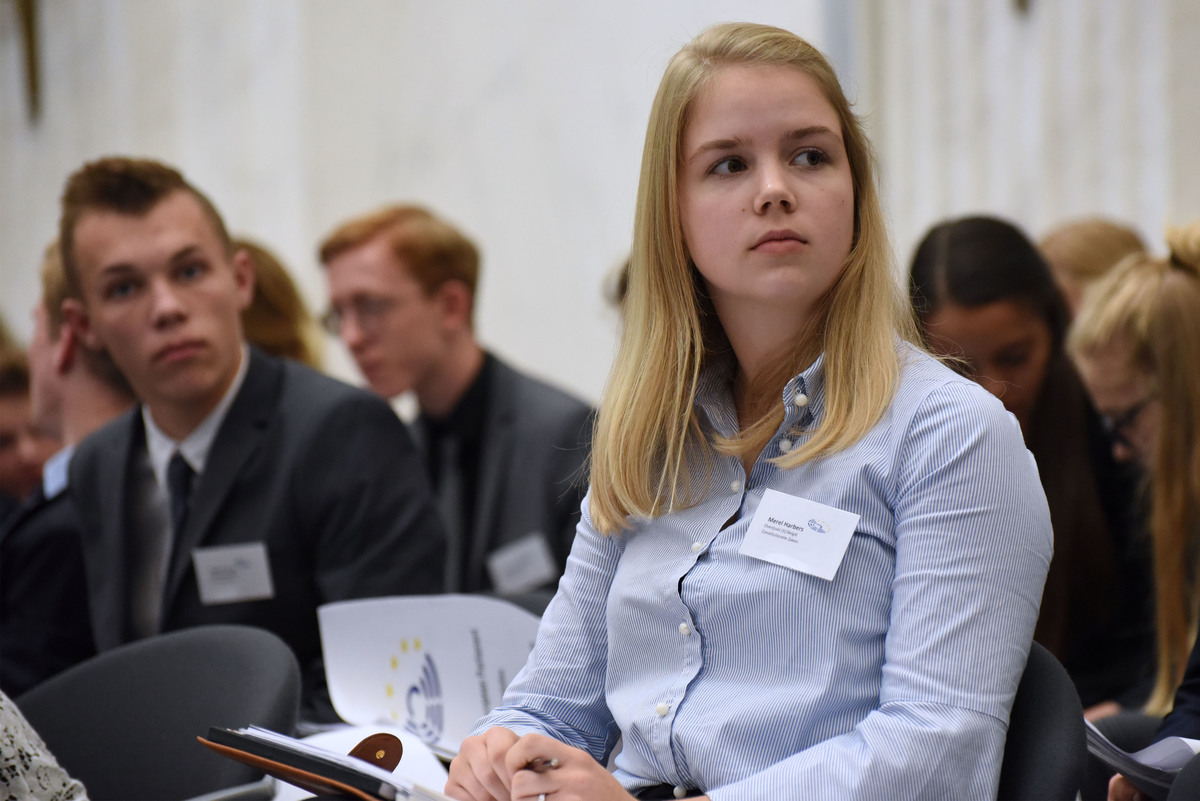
[590,23,917,534]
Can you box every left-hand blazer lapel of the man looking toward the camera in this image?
[81,408,138,650]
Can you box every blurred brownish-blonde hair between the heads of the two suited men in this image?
[234,237,324,369]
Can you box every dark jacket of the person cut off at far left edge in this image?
[0,487,96,697]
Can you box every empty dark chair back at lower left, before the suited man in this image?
[17,625,300,801]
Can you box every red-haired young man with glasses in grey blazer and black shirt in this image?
[320,205,592,612]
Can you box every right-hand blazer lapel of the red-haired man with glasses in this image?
[467,360,516,583]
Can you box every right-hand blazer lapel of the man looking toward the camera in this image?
[163,349,283,604]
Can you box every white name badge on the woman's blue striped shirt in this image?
[738,489,859,582]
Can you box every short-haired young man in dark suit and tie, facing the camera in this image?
[59,158,444,718]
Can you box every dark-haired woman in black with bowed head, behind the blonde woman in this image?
[910,217,1152,717]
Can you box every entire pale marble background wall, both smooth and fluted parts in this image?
[0,0,1200,399]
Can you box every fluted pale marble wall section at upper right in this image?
[853,0,1200,265]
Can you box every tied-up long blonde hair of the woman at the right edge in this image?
[1068,221,1200,715]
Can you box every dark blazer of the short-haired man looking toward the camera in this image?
[70,350,445,715]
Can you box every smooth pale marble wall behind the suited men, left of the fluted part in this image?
[0,0,845,401]
